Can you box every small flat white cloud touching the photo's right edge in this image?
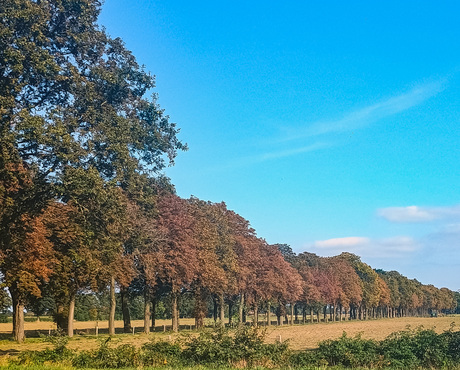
[377,205,460,223]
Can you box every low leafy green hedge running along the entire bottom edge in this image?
[11,326,460,369]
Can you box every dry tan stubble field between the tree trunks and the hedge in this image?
[0,315,460,355]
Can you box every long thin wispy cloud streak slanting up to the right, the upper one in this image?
[280,81,445,141]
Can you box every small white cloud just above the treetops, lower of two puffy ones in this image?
[311,236,420,258]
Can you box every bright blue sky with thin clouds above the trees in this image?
[100,0,460,290]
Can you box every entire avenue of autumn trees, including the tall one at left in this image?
[0,0,456,341]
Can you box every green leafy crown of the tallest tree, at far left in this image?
[0,0,186,342]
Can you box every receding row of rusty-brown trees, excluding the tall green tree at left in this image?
[4,186,456,342]
